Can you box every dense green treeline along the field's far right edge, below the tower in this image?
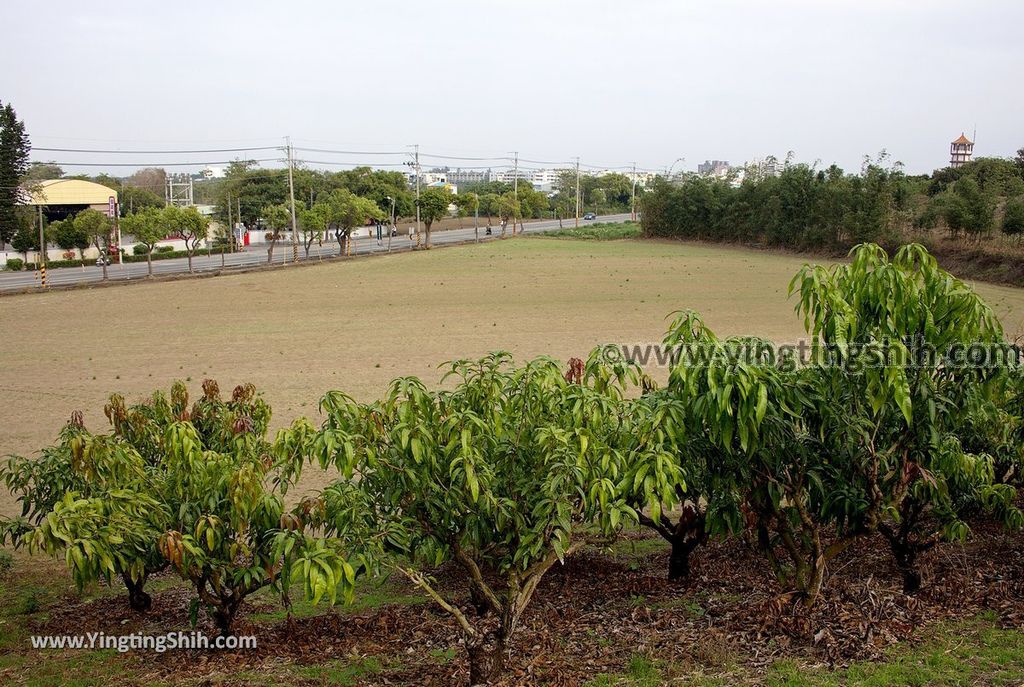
[641,154,1024,250]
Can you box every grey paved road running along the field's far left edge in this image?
[0,213,630,291]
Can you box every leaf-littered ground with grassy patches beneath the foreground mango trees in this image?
[0,521,1024,687]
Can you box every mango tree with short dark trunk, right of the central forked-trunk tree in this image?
[623,311,753,579]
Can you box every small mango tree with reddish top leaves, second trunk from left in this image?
[117,380,354,634]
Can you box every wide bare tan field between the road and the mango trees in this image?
[0,238,1024,514]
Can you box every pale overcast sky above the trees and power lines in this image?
[0,0,1024,172]
